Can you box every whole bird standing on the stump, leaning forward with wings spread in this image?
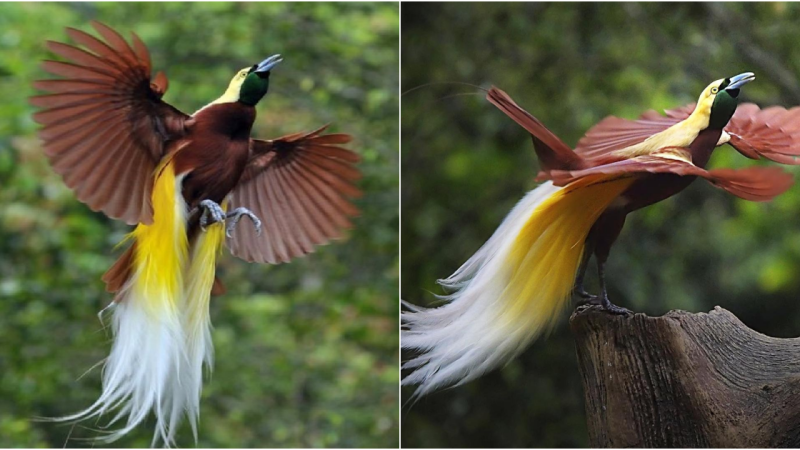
[401,73,800,397]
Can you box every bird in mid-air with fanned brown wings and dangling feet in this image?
[31,22,360,445]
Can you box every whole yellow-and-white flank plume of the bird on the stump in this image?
[401,179,631,397]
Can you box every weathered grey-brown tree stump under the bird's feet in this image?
[570,306,800,447]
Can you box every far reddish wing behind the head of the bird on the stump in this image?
[575,103,800,164]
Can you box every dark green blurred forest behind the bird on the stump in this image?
[401,3,800,447]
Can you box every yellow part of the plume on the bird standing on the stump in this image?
[500,176,633,337]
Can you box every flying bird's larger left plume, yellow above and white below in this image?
[55,165,188,446]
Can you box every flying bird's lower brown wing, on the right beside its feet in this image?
[228,127,361,264]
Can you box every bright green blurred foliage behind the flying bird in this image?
[0,3,399,447]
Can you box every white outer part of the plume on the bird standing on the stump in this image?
[401,182,561,396]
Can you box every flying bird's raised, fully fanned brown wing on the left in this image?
[31,22,191,224]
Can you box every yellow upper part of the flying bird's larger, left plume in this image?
[130,161,189,314]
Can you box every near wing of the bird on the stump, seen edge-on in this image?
[549,147,794,202]
